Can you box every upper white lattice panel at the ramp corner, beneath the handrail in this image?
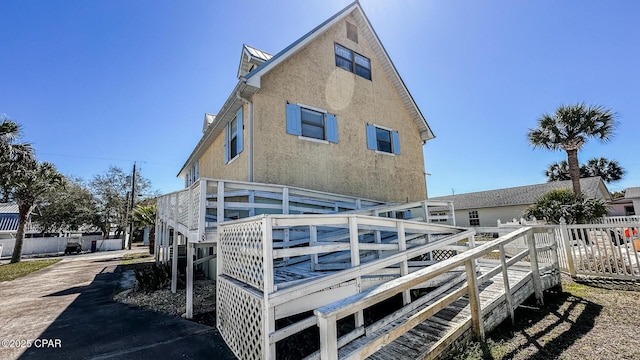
[220,221,264,291]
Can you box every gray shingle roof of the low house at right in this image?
[429,177,611,210]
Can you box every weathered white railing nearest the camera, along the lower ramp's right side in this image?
[314,227,557,360]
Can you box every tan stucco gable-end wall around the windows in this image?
[251,18,426,201]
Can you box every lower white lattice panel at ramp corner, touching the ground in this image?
[214,276,264,360]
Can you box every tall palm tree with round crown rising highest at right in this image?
[527,103,617,196]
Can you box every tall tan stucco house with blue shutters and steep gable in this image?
[178,1,434,202]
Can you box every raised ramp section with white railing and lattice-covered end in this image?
[217,214,475,359]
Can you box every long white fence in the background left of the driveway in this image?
[0,235,122,257]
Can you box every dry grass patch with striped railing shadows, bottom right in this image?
[450,278,640,359]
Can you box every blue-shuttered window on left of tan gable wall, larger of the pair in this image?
[287,104,338,143]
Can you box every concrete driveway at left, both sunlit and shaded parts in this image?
[0,251,235,359]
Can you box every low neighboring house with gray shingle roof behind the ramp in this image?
[429,177,612,226]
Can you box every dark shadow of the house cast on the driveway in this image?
[20,265,235,359]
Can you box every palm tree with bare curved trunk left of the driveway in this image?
[11,159,64,263]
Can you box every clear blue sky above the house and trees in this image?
[0,0,640,197]
